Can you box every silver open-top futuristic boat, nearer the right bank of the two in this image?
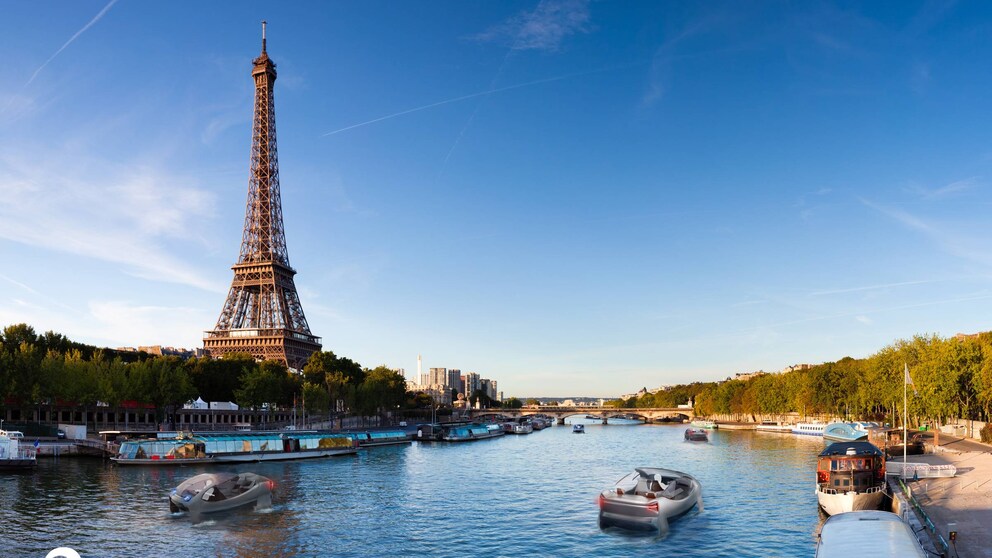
[599,467,703,533]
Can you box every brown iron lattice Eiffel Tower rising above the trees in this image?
[203,21,320,370]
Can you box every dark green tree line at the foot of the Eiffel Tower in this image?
[0,324,418,420]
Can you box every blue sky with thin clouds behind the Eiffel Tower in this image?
[0,0,992,396]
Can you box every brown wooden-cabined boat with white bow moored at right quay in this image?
[816,442,885,515]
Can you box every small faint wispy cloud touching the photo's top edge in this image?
[474,0,590,51]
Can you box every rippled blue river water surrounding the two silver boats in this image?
[0,421,823,557]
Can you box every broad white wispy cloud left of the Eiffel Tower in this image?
[0,149,224,292]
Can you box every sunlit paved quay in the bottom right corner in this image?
[897,433,992,558]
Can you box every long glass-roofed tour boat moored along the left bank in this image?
[111,431,358,465]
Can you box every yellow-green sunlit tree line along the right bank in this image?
[613,332,992,424]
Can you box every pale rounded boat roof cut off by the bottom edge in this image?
[815,510,927,558]
